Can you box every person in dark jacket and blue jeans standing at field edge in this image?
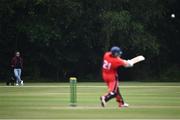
[11,52,23,86]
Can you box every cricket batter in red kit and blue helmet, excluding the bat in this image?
[100,46,133,107]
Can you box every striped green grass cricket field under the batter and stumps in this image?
[0,82,180,119]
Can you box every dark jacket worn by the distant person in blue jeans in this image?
[11,56,23,69]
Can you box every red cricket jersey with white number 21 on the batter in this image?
[102,52,126,81]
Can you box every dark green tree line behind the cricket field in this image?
[0,0,180,81]
